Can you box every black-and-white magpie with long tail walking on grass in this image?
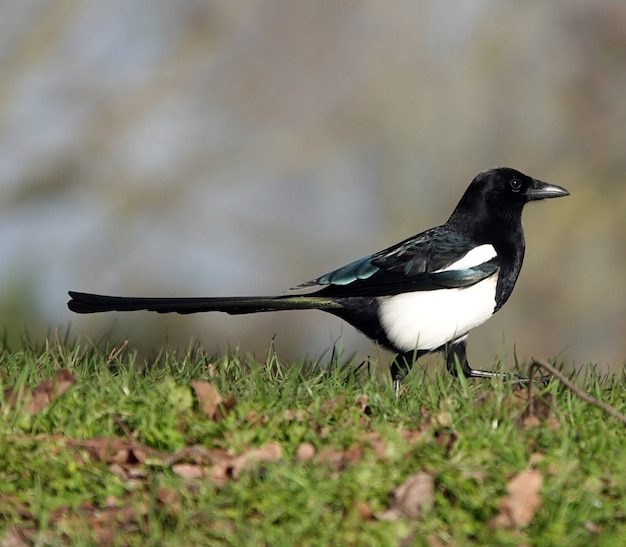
[68,167,569,392]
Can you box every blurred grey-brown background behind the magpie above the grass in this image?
[0,0,626,370]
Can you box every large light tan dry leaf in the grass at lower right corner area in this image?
[491,469,543,528]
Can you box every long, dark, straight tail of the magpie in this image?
[67,291,342,314]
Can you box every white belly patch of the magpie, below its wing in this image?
[378,275,498,351]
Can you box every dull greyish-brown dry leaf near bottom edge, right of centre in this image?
[376,472,435,520]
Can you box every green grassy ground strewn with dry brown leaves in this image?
[0,341,626,546]
